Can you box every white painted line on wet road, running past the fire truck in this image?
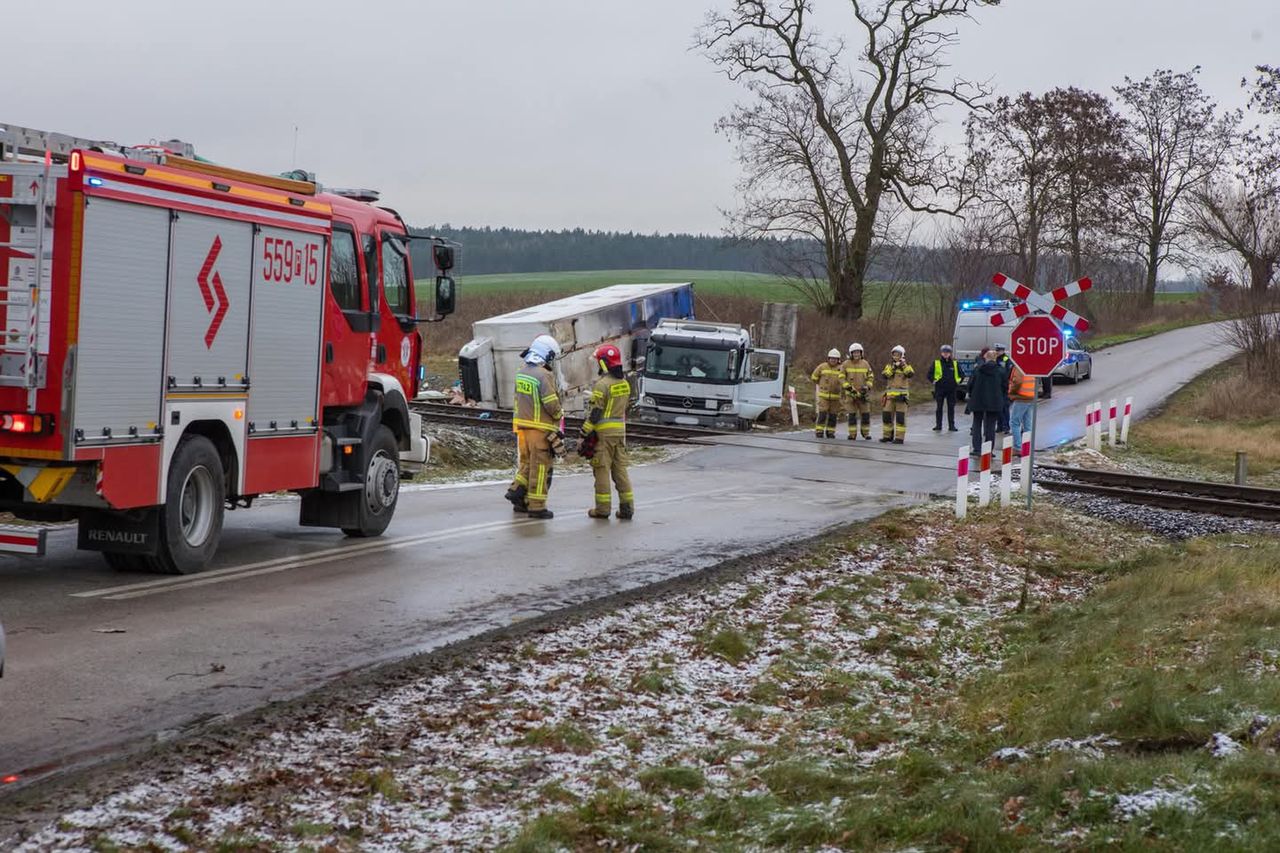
[70,489,736,601]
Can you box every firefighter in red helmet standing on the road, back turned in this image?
[577,343,636,521]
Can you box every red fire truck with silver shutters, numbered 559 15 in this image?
[0,126,454,573]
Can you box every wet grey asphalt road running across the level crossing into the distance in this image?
[0,325,1229,793]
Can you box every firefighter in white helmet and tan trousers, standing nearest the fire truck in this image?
[507,334,564,519]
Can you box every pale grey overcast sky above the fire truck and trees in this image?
[0,0,1280,233]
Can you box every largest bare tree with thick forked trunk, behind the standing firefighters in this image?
[696,0,998,319]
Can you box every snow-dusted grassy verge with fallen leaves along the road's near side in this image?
[19,501,1280,850]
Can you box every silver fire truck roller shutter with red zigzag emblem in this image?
[168,213,252,393]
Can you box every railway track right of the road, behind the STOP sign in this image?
[1036,465,1280,523]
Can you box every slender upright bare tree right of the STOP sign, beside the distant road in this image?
[1115,65,1236,310]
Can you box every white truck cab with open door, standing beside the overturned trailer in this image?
[637,319,786,429]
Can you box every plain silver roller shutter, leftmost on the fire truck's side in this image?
[73,199,170,440]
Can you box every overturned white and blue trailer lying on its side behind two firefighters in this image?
[458,282,694,412]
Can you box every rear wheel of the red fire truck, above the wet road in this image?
[145,435,227,575]
